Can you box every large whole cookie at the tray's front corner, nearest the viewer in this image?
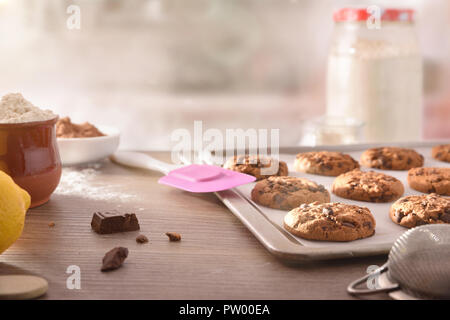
[284,202,376,241]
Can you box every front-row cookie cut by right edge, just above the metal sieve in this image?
[389,193,450,228]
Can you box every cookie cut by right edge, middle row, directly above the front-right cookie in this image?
[408,168,450,196]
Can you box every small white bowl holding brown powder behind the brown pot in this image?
[57,126,120,166]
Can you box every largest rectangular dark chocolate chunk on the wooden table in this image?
[91,212,140,234]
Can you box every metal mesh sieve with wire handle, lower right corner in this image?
[347,224,450,299]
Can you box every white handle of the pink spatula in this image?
[111,151,179,174]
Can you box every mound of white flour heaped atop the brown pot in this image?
[0,93,56,123]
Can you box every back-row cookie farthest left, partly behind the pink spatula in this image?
[223,155,288,180]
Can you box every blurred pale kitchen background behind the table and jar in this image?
[0,0,450,149]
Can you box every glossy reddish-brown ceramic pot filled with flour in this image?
[0,118,61,208]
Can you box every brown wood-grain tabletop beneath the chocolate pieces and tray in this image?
[0,153,388,299]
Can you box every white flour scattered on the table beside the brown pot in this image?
[55,163,136,202]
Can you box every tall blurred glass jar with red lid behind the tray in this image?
[326,8,422,142]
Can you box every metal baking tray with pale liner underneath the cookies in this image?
[212,141,450,262]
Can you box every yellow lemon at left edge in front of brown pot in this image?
[0,171,31,254]
